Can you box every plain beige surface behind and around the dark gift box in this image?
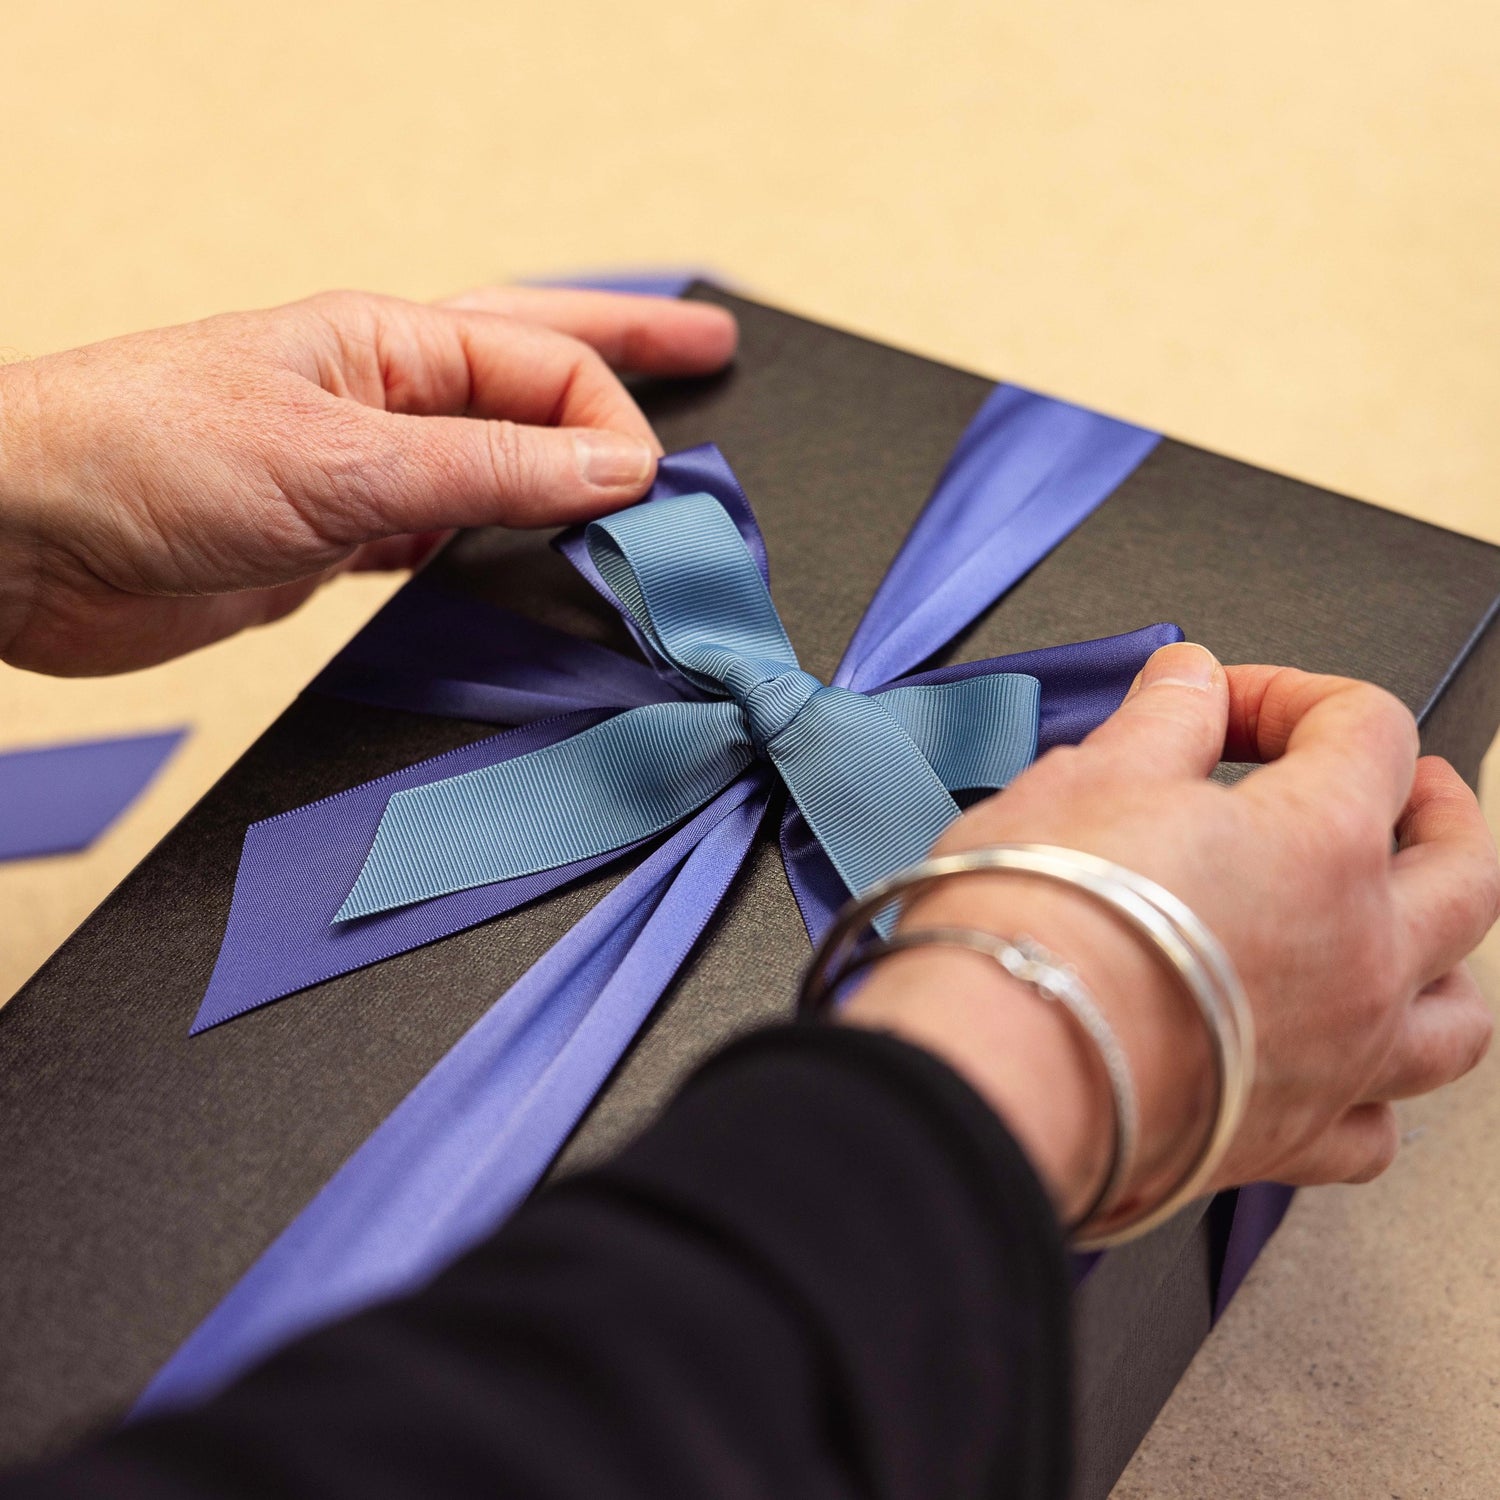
[0,0,1500,1500]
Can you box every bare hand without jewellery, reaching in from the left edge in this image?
[0,288,737,675]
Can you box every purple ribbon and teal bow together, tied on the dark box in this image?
[140,387,1218,1412]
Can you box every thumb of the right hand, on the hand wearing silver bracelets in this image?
[1083,642,1229,780]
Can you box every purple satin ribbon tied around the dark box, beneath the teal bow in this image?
[137,387,1182,1412]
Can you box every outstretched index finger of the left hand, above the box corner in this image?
[438,287,740,375]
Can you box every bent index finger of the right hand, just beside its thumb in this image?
[1224,666,1419,825]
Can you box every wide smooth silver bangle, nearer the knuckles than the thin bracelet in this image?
[798,845,1256,1250]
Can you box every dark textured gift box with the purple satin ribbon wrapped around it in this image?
[11,287,1500,1500]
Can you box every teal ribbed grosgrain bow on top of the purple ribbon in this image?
[336,494,1040,921]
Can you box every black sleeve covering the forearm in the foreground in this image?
[0,1026,1070,1500]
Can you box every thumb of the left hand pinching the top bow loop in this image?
[345,411,659,542]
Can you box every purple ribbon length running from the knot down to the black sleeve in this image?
[141,777,767,1419]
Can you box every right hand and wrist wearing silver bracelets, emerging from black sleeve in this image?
[843,645,1500,1220]
